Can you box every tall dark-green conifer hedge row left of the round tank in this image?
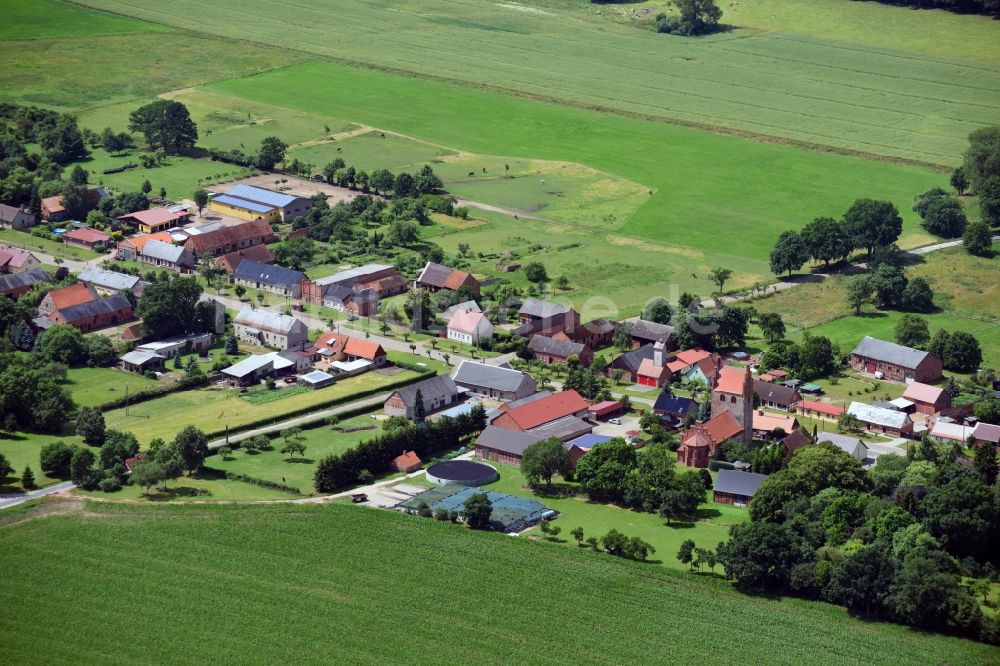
[316,405,486,493]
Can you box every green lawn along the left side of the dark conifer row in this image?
[207,412,382,495]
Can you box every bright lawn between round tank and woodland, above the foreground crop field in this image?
[487,465,749,569]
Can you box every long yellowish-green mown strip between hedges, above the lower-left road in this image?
[105,370,417,444]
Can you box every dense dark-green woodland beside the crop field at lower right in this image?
[717,440,1000,641]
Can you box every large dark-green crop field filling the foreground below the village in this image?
[0,502,996,665]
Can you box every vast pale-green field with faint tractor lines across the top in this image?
[72,0,1000,164]
